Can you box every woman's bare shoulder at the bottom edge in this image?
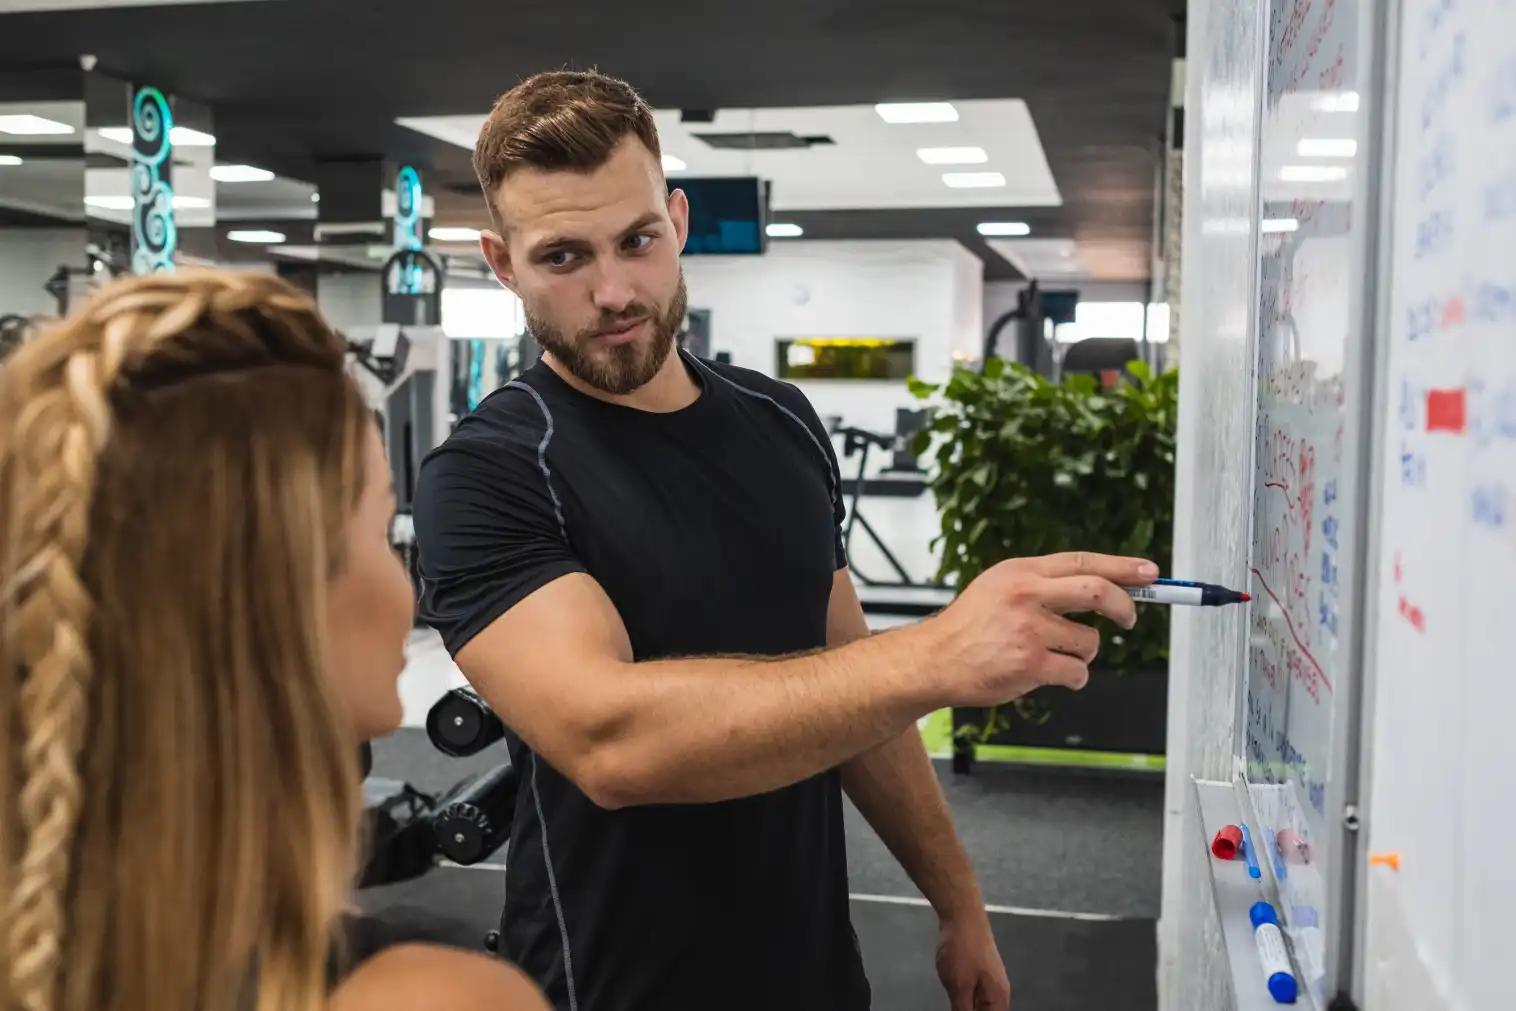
[329,944,552,1011]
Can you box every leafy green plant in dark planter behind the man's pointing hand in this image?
[911,359,1178,763]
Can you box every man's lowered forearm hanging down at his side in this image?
[843,725,984,920]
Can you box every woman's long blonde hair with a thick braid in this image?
[0,273,373,1011]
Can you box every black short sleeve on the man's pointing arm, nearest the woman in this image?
[414,437,585,655]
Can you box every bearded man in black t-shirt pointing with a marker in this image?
[415,73,1157,1011]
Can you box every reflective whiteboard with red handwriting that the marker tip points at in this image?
[1240,0,1372,1008]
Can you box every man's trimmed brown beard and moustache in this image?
[523,273,690,397]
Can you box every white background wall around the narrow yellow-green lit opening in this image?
[684,241,984,581]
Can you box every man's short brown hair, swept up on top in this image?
[473,70,662,224]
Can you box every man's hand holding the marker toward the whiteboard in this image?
[922,552,1158,706]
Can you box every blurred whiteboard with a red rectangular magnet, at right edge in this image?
[1364,0,1516,1011]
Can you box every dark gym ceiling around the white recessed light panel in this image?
[0,0,1182,280]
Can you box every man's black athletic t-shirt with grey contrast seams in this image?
[415,352,869,1011]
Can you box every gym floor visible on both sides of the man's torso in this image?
[362,635,1163,1011]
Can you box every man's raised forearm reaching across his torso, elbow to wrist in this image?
[569,626,943,806]
